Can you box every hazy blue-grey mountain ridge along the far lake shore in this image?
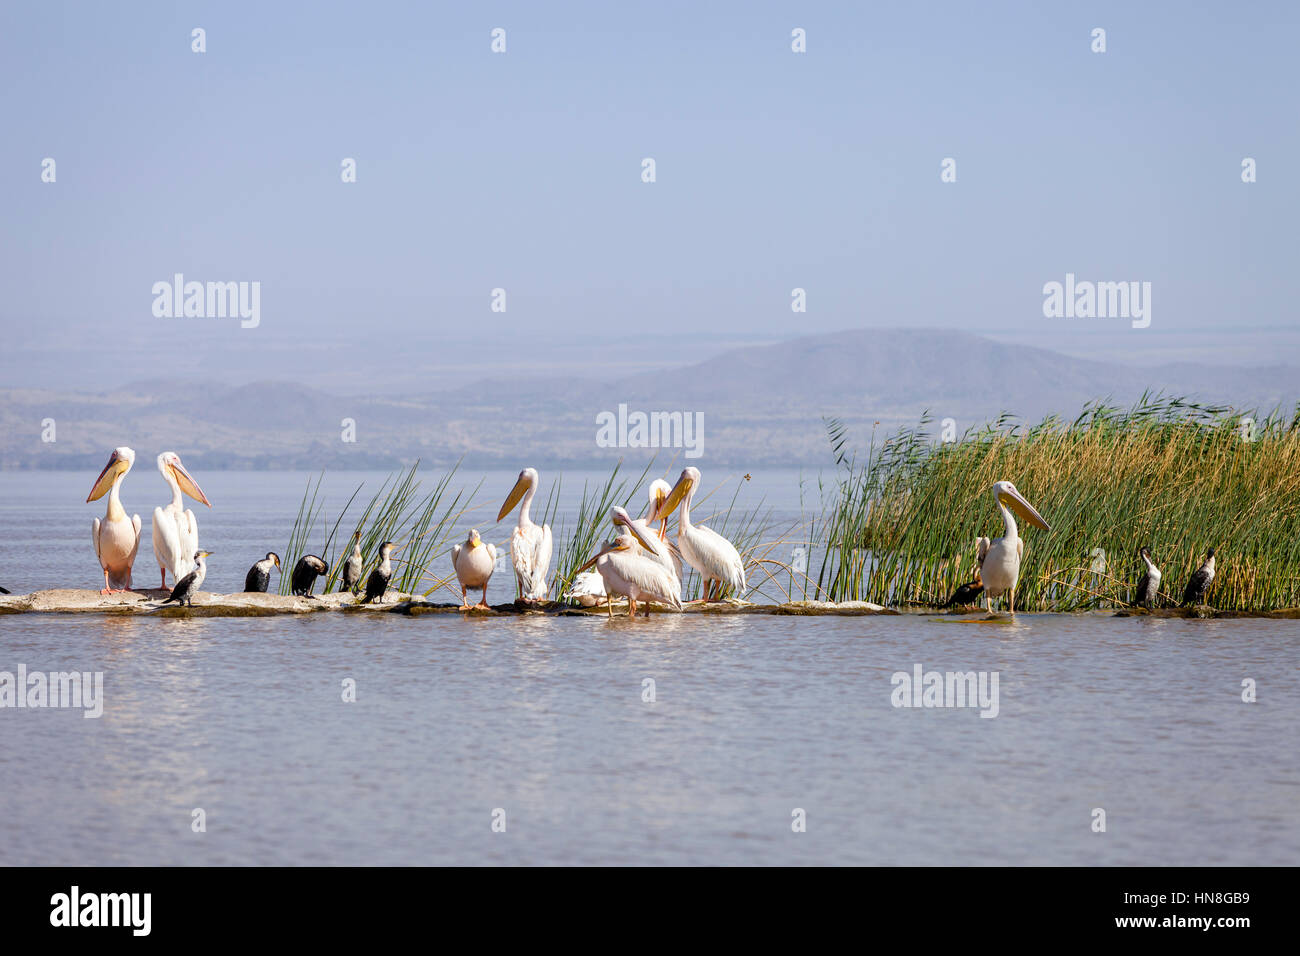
[0,329,1300,468]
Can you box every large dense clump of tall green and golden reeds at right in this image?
[818,394,1300,611]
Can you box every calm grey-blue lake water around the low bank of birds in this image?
[0,466,1300,865]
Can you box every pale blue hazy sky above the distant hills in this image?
[0,3,1300,388]
